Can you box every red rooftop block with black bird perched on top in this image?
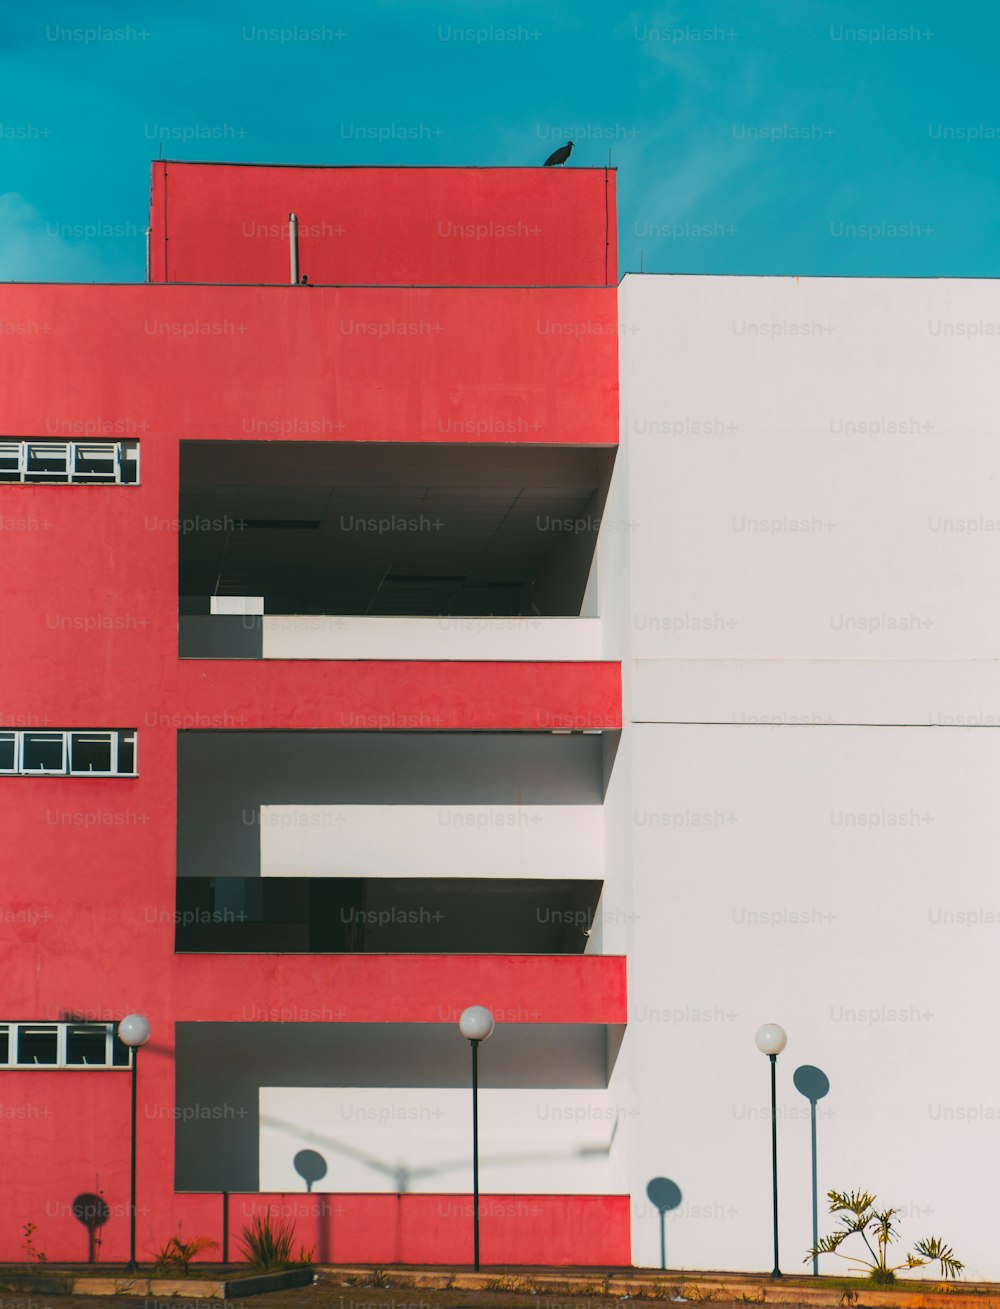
[149,162,618,287]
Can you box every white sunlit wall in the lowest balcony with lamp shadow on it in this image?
[260,1086,624,1195]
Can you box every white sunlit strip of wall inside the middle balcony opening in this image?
[260,805,605,881]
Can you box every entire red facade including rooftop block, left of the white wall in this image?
[0,162,630,1263]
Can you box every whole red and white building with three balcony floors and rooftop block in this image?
[0,161,1000,1276]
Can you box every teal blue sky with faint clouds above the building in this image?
[0,0,1000,281]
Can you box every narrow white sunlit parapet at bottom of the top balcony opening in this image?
[263,614,601,662]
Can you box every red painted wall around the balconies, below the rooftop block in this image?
[0,163,628,1262]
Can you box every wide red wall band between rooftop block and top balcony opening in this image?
[0,284,619,446]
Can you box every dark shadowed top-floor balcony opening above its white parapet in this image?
[179,441,614,657]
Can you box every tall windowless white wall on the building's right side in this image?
[617,276,1000,1278]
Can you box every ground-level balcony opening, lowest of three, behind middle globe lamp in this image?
[174,1021,624,1195]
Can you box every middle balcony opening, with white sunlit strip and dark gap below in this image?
[175,732,609,954]
